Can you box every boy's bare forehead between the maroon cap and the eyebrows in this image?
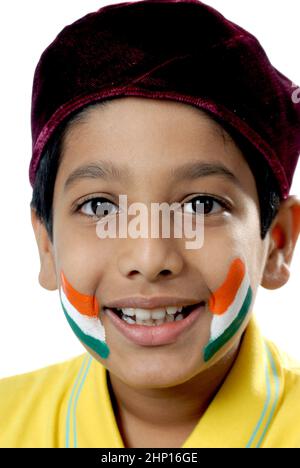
[61,96,253,194]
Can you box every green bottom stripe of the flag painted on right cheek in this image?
[204,286,252,362]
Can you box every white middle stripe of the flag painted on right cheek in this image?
[210,273,250,340]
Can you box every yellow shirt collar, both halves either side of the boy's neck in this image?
[66,316,283,448]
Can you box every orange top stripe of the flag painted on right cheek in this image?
[209,258,245,315]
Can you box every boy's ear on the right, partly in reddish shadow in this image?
[261,196,300,289]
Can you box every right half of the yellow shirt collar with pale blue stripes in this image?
[182,316,283,448]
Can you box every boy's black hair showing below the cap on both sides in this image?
[30,99,280,241]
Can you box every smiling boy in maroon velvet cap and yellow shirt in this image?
[0,0,300,448]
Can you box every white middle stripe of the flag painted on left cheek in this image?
[60,288,105,341]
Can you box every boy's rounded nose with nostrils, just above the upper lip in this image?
[118,238,184,282]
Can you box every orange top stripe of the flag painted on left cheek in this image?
[61,272,99,317]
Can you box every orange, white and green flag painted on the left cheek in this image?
[60,272,109,358]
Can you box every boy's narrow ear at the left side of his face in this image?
[31,208,57,291]
